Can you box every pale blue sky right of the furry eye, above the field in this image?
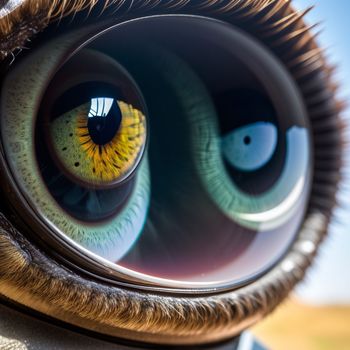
[294,0,350,304]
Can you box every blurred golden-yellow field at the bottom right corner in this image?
[253,300,350,350]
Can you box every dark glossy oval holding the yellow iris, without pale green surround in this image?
[40,50,147,193]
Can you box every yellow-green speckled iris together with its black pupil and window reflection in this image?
[50,98,146,184]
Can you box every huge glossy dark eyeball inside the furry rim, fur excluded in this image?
[2,16,311,291]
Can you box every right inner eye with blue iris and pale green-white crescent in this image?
[191,85,309,231]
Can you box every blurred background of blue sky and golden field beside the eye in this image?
[254,0,350,350]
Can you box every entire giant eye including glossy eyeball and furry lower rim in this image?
[0,2,340,344]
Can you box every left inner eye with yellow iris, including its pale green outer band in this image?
[3,43,150,261]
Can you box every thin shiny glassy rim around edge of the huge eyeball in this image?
[3,14,312,295]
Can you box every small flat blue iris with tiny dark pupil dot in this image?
[221,122,277,171]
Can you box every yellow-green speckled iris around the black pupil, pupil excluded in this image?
[51,101,146,185]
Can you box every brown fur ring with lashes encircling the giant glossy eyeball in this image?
[0,0,342,343]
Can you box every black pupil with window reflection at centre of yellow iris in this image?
[88,99,122,145]
